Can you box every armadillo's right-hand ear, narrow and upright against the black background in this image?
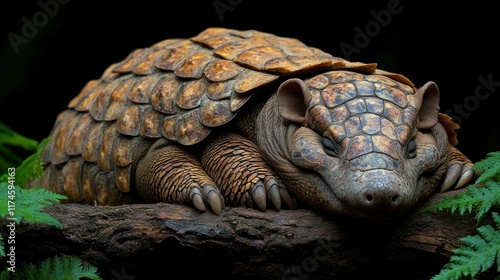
[415,82,439,129]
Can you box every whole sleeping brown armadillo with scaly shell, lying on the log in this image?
[37,28,473,220]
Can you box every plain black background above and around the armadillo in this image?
[0,0,500,161]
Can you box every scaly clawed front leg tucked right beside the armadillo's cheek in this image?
[201,133,295,211]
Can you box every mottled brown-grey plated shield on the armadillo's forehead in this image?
[306,70,418,169]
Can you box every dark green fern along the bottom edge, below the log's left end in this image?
[2,256,102,280]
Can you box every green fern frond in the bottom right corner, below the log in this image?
[432,212,500,280]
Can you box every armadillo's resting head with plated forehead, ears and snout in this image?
[277,71,448,220]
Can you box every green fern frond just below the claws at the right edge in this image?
[423,181,500,220]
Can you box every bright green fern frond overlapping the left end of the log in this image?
[0,182,67,228]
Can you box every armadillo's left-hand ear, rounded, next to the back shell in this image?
[277,79,312,125]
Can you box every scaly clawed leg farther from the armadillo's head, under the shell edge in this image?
[136,139,224,214]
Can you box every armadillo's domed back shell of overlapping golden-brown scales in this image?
[42,28,413,204]
